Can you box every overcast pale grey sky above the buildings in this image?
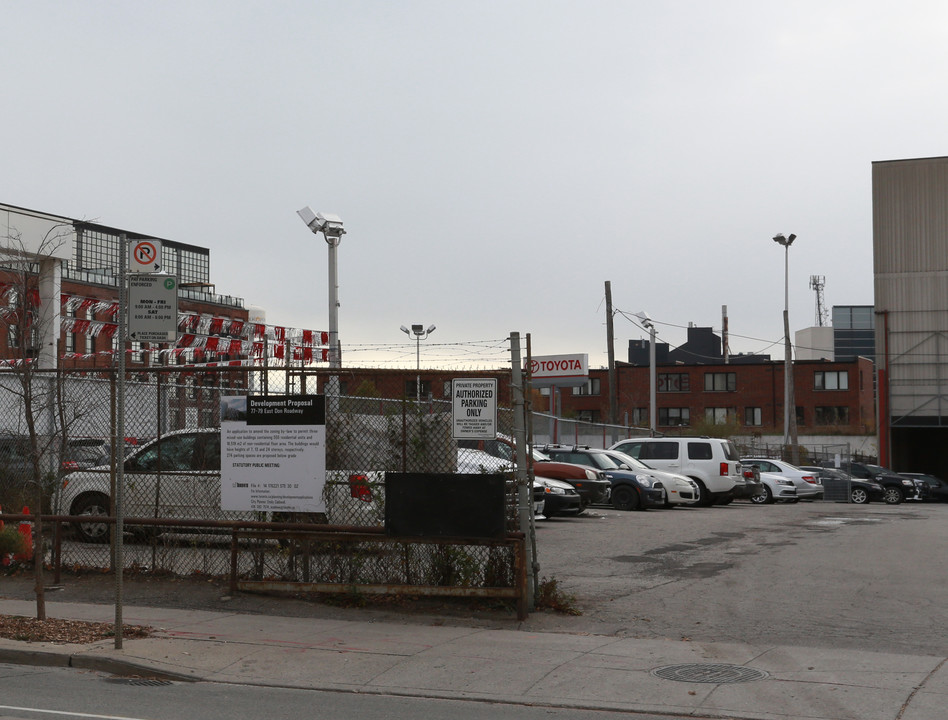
[0,0,948,369]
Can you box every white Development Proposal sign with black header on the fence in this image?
[221,395,326,513]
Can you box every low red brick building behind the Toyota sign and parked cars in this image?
[310,357,875,435]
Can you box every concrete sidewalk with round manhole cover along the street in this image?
[0,599,948,720]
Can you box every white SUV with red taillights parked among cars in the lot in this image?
[609,437,744,505]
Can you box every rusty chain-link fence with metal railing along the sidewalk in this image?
[0,368,529,602]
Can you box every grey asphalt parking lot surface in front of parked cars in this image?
[537,501,948,654]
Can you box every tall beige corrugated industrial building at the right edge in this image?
[872,157,948,477]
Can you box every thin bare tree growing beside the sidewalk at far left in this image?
[0,224,75,620]
